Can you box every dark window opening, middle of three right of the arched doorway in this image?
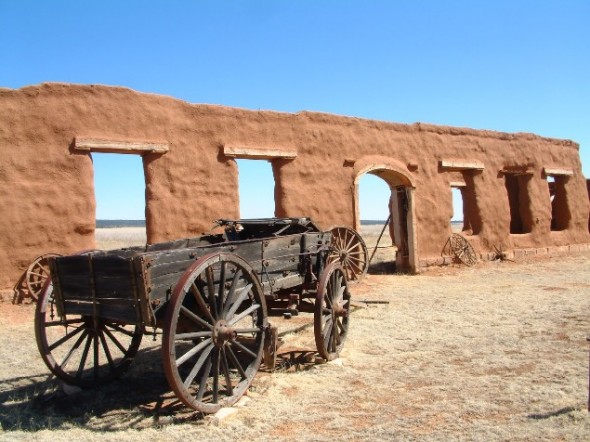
[504,173,533,234]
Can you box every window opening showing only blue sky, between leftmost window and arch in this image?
[236,159,275,219]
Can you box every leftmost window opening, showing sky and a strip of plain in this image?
[91,152,146,250]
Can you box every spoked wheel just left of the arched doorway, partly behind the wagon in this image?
[328,226,369,281]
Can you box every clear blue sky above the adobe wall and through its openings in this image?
[0,0,590,219]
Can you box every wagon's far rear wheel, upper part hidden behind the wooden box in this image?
[35,280,142,388]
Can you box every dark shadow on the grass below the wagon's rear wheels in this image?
[0,347,204,432]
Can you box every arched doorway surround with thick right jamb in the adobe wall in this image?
[354,161,417,272]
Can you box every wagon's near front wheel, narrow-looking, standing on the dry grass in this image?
[313,263,350,360]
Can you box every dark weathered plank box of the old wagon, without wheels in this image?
[52,219,331,332]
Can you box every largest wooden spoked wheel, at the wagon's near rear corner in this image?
[162,252,267,413]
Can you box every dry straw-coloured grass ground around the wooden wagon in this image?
[0,226,590,442]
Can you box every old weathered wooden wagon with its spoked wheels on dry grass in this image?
[35,218,367,413]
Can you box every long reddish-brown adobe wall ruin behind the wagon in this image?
[0,84,590,288]
